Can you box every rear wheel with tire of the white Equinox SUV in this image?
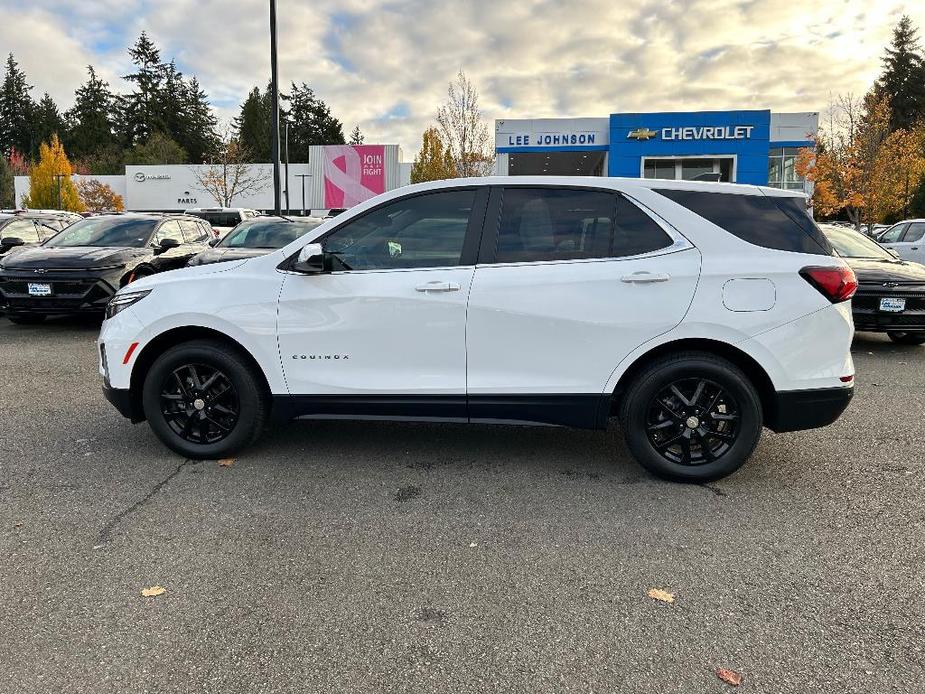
[620,352,763,483]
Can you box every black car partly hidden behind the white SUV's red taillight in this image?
[819,224,925,345]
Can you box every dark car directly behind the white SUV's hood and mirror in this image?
[189,217,324,266]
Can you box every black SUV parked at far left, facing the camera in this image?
[0,214,212,323]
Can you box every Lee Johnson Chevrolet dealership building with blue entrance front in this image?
[495,109,819,192]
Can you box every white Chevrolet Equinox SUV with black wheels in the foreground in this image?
[99,177,856,481]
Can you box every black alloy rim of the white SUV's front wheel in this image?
[161,364,241,444]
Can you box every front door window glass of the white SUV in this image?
[324,190,475,270]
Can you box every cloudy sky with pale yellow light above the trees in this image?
[0,0,925,155]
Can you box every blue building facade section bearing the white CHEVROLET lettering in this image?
[608,110,771,185]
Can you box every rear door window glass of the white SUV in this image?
[495,188,672,263]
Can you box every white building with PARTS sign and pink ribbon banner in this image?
[15,145,411,214]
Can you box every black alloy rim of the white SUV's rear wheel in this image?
[646,378,739,465]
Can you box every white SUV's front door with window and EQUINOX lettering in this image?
[278,188,487,418]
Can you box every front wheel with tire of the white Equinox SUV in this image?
[142,340,268,459]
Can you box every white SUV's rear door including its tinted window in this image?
[466,186,700,425]
